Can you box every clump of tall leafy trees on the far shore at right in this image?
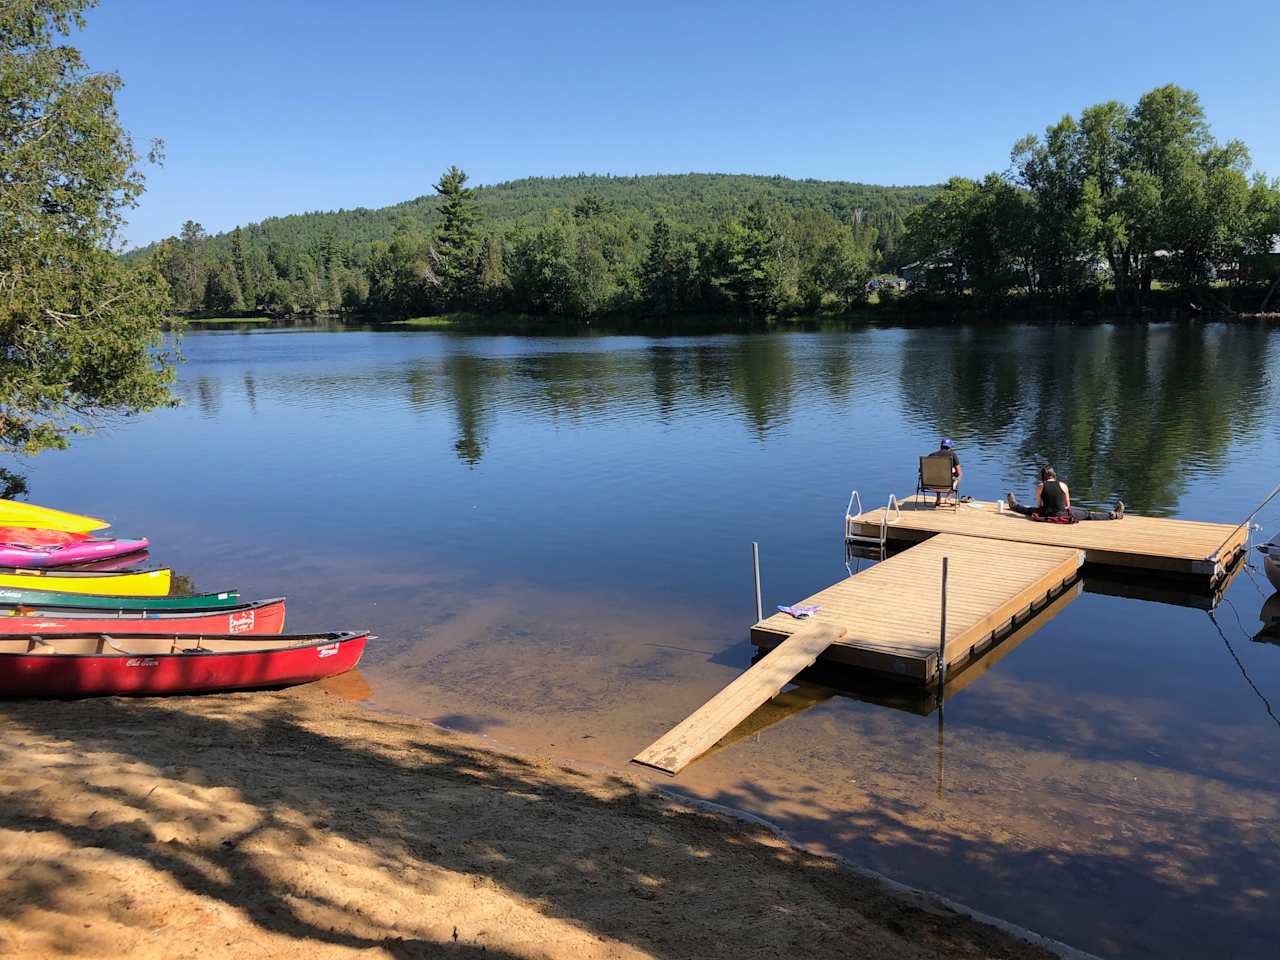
[905,86,1280,307]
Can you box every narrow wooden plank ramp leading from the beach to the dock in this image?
[632,622,846,776]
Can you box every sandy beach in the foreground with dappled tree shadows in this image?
[0,686,1050,960]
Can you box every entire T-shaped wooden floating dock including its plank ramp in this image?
[634,493,1244,776]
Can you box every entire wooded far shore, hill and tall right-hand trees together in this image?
[142,86,1280,320]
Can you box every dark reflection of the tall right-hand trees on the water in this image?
[900,324,1271,515]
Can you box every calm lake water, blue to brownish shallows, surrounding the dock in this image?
[17,324,1280,957]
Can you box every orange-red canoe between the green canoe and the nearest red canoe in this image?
[0,596,284,634]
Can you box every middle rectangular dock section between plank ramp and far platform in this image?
[751,534,1084,684]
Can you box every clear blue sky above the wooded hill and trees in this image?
[76,0,1280,243]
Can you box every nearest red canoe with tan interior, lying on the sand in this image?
[0,634,369,696]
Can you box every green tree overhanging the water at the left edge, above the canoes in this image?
[0,0,173,452]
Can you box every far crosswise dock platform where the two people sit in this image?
[845,497,1248,580]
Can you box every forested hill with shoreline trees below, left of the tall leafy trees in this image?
[137,168,940,319]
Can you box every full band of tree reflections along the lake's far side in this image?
[192,323,1275,513]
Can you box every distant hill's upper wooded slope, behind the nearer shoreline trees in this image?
[131,173,938,256]
